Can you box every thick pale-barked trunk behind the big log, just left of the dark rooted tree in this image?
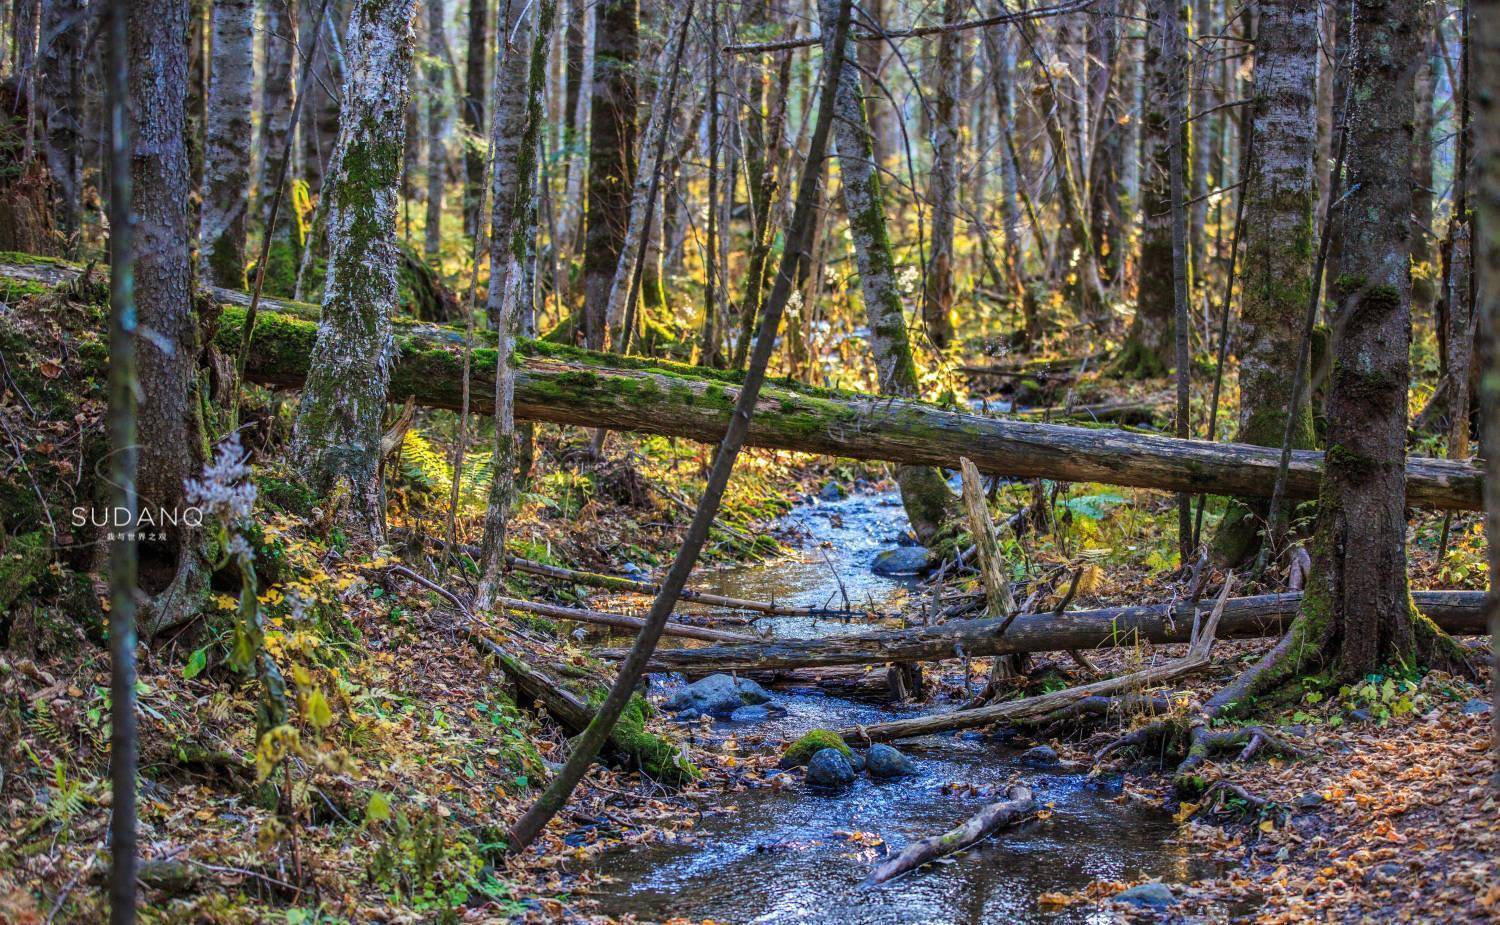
[1214,0,1319,565]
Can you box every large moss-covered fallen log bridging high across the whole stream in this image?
[0,259,1482,510]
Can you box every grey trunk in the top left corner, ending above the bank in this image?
[36,0,84,241]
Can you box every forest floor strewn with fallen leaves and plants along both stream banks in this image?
[0,298,1500,925]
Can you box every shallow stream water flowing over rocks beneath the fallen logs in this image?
[594,493,1209,925]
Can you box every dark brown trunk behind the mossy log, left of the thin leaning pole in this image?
[584,0,641,349]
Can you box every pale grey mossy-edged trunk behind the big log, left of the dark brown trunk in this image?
[485,3,537,331]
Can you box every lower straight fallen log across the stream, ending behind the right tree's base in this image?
[599,591,1490,673]
